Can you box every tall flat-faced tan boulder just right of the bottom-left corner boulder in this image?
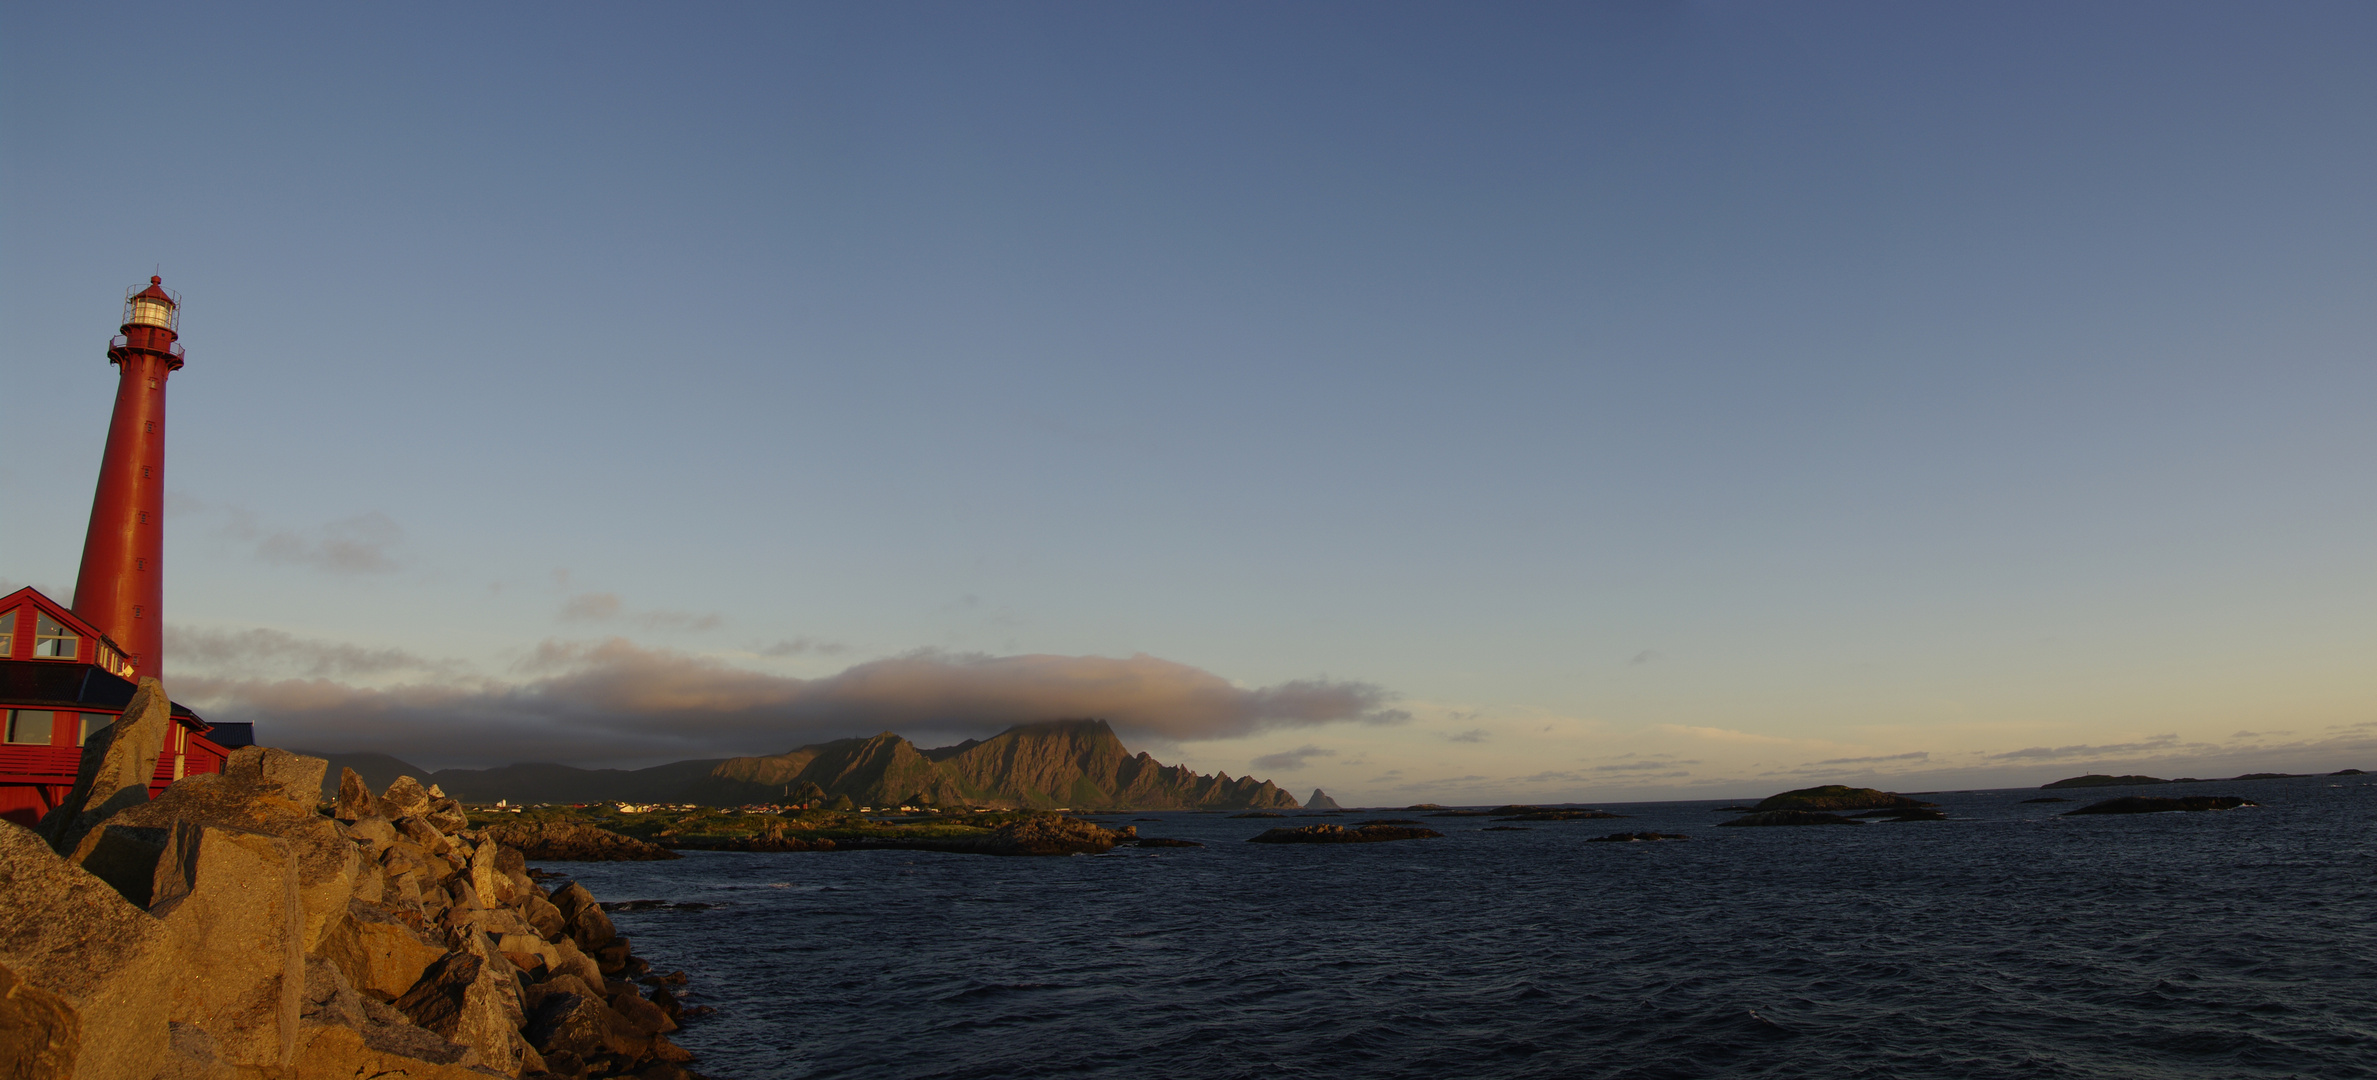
[150,821,304,1070]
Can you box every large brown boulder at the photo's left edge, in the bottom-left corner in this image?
[0,821,176,1080]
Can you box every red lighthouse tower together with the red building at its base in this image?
[0,278,252,825]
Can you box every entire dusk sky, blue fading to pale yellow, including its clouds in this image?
[0,2,2377,802]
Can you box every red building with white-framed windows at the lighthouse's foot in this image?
[0,588,250,825]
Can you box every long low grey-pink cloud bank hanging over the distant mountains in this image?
[185,638,1407,766]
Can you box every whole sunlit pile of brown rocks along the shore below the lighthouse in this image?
[0,680,692,1080]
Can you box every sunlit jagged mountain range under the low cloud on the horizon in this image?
[323,721,1298,809]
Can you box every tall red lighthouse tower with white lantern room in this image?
[74,278,183,678]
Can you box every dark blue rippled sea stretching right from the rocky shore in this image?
[547,776,2377,1080]
